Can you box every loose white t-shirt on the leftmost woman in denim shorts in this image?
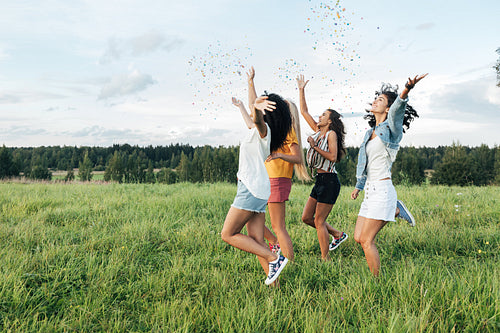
[237,124,271,200]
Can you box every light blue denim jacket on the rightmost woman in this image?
[356,95,408,191]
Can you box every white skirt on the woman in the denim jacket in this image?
[358,179,398,222]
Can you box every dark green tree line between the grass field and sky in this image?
[0,143,500,186]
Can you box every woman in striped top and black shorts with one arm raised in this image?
[297,75,347,260]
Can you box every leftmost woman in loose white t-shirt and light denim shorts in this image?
[221,94,292,285]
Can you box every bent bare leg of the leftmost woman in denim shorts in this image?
[221,207,278,262]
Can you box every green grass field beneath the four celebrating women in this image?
[0,183,500,332]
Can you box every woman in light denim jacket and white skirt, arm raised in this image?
[351,74,427,276]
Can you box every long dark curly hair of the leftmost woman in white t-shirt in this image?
[264,93,292,152]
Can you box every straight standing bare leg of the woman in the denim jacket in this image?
[354,216,387,276]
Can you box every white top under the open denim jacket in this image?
[366,135,392,181]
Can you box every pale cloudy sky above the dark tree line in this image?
[0,0,500,147]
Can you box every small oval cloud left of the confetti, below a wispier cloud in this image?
[98,70,156,100]
